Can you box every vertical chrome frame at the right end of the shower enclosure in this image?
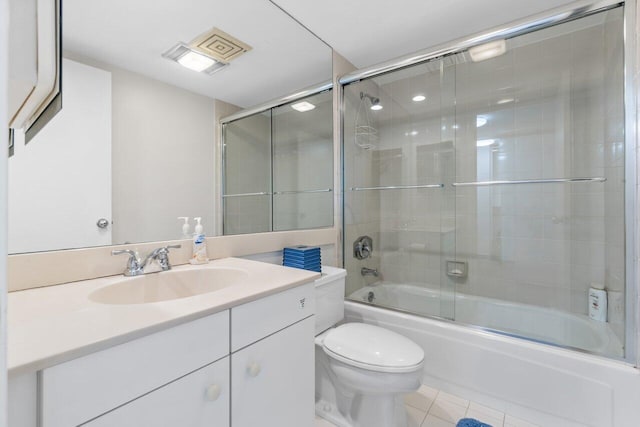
[624,0,640,366]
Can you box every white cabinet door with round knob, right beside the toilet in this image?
[231,316,315,427]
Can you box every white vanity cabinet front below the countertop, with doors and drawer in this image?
[9,283,315,427]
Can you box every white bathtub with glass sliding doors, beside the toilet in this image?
[345,284,640,427]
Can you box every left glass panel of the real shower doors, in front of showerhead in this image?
[343,59,456,319]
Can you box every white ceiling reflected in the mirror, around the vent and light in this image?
[62,0,332,107]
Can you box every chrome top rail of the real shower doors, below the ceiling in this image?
[339,0,624,85]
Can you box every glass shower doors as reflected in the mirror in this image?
[222,90,333,235]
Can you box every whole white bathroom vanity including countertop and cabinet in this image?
[9,258,319,427]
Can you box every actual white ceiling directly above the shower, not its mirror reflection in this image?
[272,0,573,68]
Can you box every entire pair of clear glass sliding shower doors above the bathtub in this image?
[343,7,635,358]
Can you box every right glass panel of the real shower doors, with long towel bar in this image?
[454,7,625,356]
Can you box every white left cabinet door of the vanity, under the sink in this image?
[83,356,229,427]
